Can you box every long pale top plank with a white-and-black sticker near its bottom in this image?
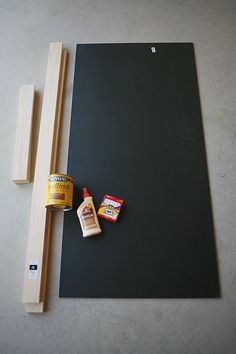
[23,42,63,306]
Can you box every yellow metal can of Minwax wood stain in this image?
[46,173,74,211]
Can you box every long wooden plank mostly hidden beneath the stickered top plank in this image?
[25,49,67,313]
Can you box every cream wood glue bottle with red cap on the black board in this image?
[77,188,102,237]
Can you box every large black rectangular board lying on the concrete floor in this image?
[60,43,220,298]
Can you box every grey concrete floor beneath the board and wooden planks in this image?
[0,0,236,354]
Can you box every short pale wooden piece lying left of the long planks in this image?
[12,85,35,183]
